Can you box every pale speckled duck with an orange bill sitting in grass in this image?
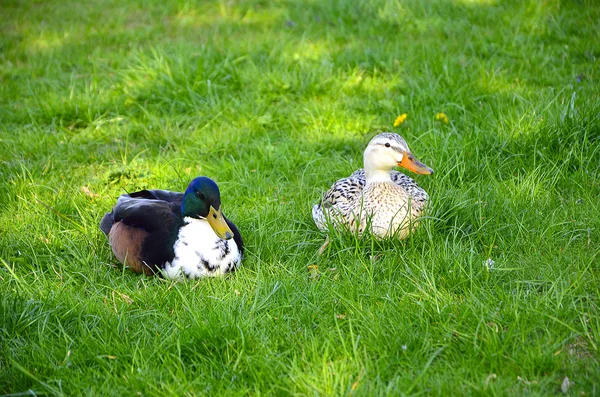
[312,132,433,252]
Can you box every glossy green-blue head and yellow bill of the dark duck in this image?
[181,176,233,240]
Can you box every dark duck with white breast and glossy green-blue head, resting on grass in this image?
[100,177,244,278]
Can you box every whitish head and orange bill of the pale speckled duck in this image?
[364,132,433,179]
